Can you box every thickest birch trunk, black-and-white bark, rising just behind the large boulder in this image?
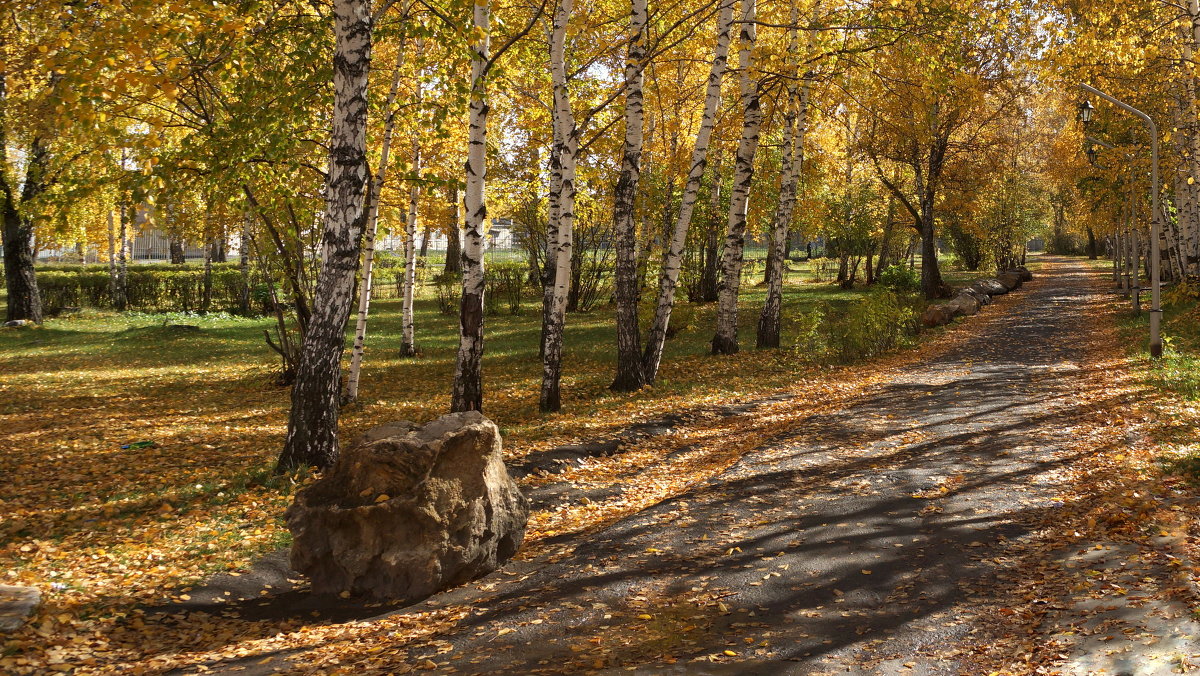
[276,0,372,472]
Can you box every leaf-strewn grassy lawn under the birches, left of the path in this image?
[0,259,907,612]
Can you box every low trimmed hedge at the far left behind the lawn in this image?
[37,264,245,312]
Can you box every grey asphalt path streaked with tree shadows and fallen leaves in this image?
[192,261,1194,675]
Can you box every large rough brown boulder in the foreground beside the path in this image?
[287,412,529,602]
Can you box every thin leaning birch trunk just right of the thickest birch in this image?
[342,49,404,403]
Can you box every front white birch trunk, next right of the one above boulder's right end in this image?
[538,0,580,413]
